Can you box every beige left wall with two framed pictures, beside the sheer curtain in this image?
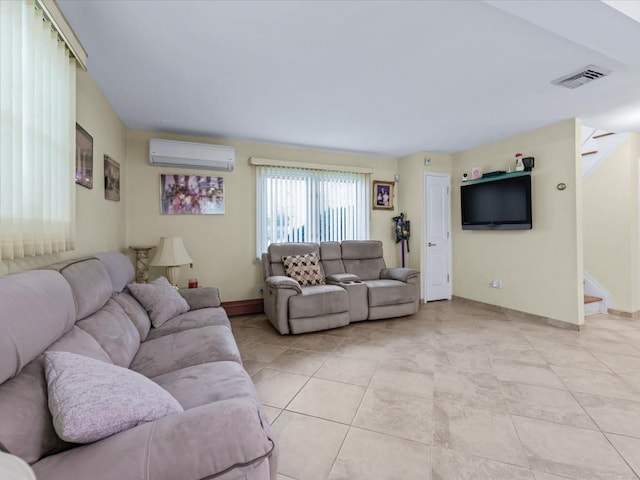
[0,70,127,274]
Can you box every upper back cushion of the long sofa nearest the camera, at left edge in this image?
[0,270,76,386]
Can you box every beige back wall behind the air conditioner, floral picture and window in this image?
[126,131,399,301]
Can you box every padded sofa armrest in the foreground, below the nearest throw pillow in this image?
[32,398,274,480]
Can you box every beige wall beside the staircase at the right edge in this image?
[583,134,640,312]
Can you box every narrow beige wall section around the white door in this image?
[398,152,455,299]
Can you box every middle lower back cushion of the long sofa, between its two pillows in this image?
[77,299,140,367]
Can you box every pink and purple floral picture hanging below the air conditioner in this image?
[160,174,224,215]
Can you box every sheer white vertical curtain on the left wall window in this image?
[0,0,76,259]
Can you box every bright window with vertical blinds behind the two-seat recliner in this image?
[256,166,369,257]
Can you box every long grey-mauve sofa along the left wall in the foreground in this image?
[0,252,277,480]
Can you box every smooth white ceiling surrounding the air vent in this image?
[58,0,640,157]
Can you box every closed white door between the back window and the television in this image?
[423,174,451,302]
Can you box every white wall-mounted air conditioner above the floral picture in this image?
[149,138,236,172]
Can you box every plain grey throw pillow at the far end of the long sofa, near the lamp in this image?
[127,277,189,328]
